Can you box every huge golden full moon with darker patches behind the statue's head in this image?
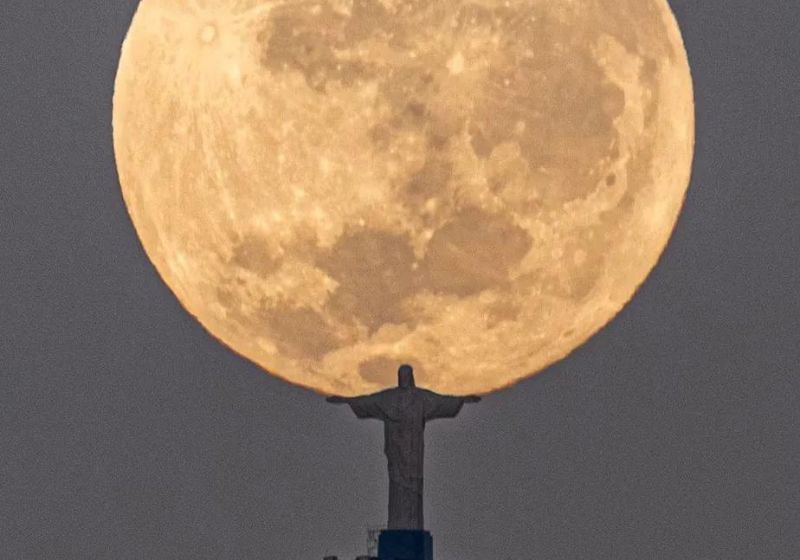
[113,0,694,395]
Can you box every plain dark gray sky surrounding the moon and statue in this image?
[0,0,800,560]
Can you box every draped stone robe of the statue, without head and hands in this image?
[347,387,464,530]
